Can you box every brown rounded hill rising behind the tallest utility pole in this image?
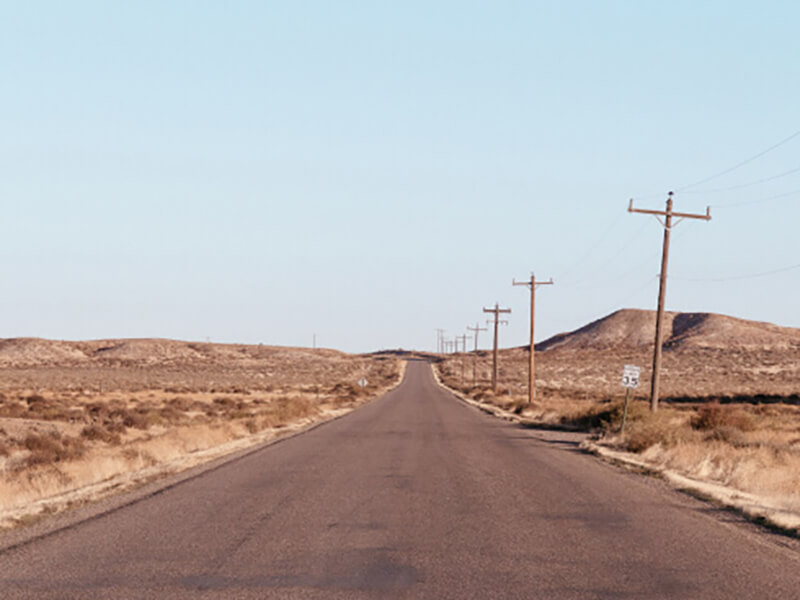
[536,309,800,350]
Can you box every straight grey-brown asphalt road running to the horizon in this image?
[0,363,800,600]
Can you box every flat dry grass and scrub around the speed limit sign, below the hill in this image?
[437,348,800,512]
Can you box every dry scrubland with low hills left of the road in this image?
[0,338,403,526]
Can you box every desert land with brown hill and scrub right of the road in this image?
[437,310,800,528]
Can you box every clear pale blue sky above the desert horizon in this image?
[0,0,800,351]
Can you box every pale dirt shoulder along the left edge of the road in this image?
[0,360,408,553]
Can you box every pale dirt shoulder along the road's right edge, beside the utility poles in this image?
[430,363,800,539]
